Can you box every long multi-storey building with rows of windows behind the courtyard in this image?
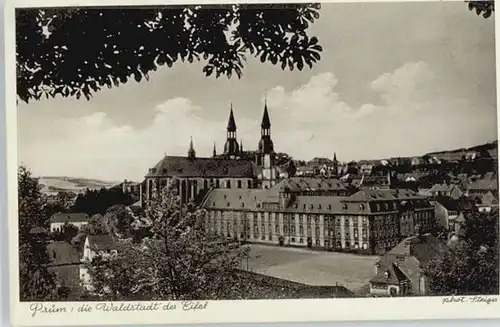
[202,183,434,254]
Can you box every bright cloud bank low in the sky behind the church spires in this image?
[19,62,496,180]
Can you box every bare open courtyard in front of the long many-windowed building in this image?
[242,244,379,292]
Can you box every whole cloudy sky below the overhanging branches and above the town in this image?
[18,1,497,181]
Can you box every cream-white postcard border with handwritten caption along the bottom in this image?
[5,0,500,326]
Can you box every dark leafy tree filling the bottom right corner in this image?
[424,212,499,295]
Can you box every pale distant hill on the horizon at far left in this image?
[39,176,119,194]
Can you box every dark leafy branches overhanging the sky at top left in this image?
[16,4,322,102]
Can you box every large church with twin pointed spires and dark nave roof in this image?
[140,101,279,203]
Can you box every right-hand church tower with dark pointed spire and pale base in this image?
[256,100,276,188]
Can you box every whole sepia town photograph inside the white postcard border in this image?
[7,1,499,326]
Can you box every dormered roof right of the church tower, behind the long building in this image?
[275,177,347,192]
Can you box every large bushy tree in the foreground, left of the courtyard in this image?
[89,181,249,300]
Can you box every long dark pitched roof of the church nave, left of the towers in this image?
[146,156,256,178]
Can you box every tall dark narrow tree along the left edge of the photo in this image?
[17,166,55,301]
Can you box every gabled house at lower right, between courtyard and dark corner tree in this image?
[370,228,448,296]
